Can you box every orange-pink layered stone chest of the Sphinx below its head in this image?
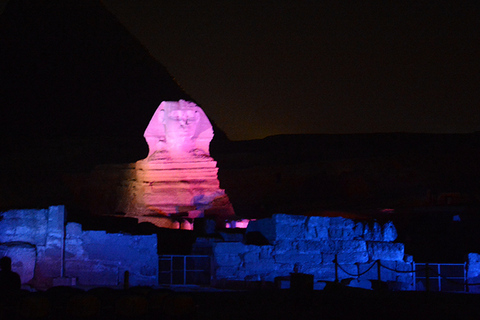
[127,157,234,226]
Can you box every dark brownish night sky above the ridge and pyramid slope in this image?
[0,0,480,140]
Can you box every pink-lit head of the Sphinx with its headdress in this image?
[144,100,213,161]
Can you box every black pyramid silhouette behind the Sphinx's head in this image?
[0,0,231,209]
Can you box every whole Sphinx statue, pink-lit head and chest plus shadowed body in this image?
[76,100,238,229]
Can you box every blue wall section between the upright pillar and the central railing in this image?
[65,223,158,286]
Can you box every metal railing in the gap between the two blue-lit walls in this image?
[158,255,212,285]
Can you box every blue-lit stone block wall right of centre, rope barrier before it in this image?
[194,214,413,290]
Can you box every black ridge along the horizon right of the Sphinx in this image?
[219,132,480,167]
